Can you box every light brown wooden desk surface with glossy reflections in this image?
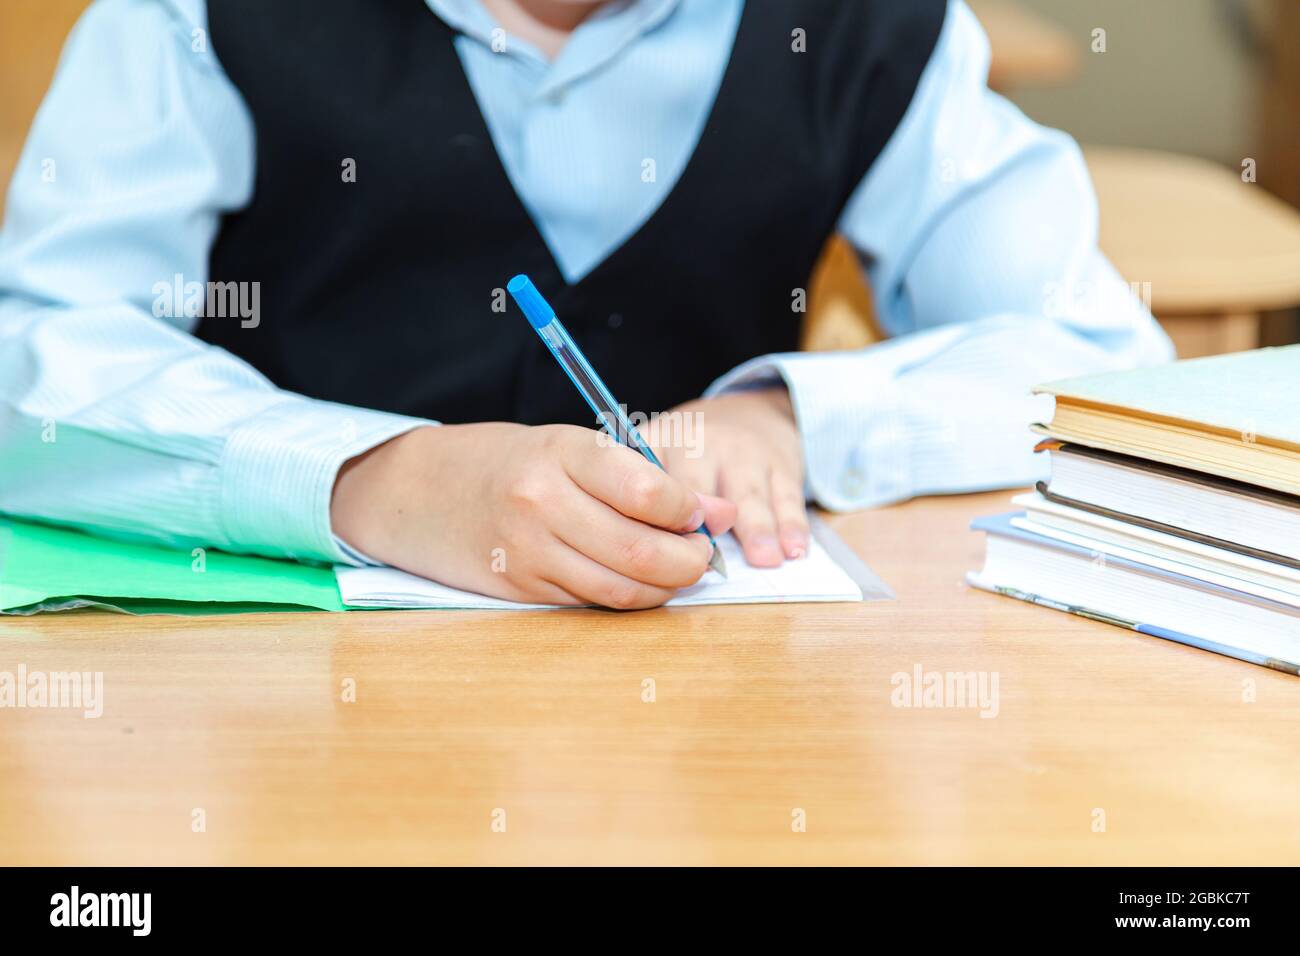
[0,493,1300,865]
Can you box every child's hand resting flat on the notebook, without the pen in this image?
[644,388,809,567]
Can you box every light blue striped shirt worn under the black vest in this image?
[0,0,1171,562]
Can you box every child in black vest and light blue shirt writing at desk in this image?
[0,0,1170,607]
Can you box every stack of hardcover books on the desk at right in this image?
[967,346,1300,675]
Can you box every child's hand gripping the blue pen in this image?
[330,421,736,609]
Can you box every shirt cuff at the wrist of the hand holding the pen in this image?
[221,395,437,564]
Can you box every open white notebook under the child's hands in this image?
[334,522,893,610]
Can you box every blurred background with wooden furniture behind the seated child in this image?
[0,0,1300,356]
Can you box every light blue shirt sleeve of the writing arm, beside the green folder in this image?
[0,0,429,563]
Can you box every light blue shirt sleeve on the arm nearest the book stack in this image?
[707,0,1173,510]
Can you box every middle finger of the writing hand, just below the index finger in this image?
[554,490,712,588]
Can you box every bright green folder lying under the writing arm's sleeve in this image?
[0,518,345,614]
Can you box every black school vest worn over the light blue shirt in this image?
[198,0,945,424]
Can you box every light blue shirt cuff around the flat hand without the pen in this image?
[705,351,913,511]
